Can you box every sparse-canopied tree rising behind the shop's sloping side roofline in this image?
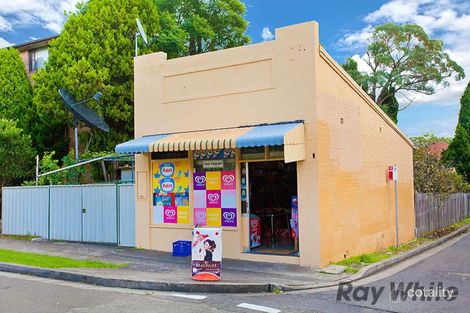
[348,23,465,120]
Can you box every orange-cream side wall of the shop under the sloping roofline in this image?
[316,50,415,265]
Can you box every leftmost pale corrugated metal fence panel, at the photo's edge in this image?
[2,186,49,238]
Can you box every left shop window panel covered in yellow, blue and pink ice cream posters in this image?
[152,159,190,224]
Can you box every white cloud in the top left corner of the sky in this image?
[0,0,79,33]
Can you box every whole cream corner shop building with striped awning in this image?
[116,22,415,266]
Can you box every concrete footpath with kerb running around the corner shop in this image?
[0,227,468,293]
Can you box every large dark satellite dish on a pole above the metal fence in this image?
[59,88,109,160]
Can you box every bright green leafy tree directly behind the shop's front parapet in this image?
[155,0,250,55]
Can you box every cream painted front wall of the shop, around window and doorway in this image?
[135,22,320,266]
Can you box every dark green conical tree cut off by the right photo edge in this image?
[444,83,470,182]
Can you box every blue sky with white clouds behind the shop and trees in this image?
[0,0,470,136]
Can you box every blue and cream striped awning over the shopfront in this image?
[116,121,305,162]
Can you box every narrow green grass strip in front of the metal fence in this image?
[0,249,127,268]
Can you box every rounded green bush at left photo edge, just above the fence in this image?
[0,118,34,188]
